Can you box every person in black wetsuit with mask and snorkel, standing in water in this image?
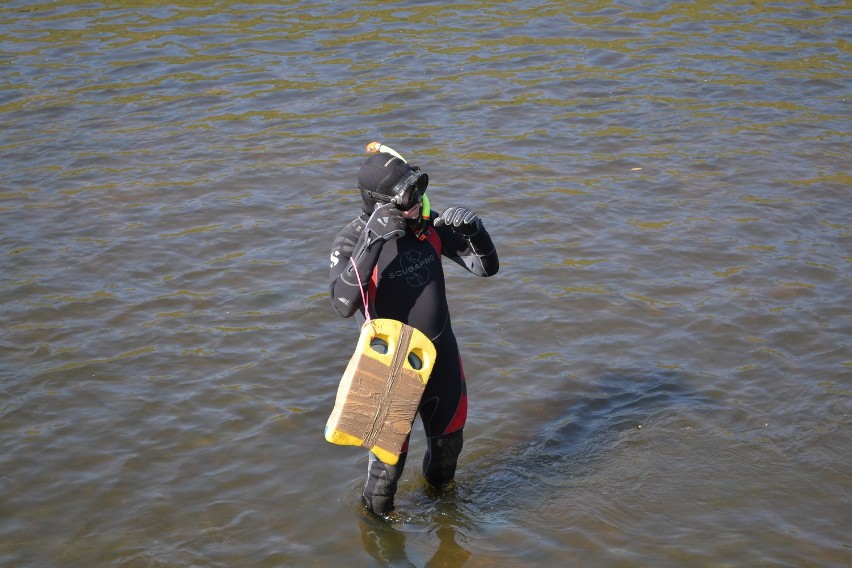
[330,143,499,515]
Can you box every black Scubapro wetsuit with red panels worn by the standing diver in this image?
[330,206,499,514]
